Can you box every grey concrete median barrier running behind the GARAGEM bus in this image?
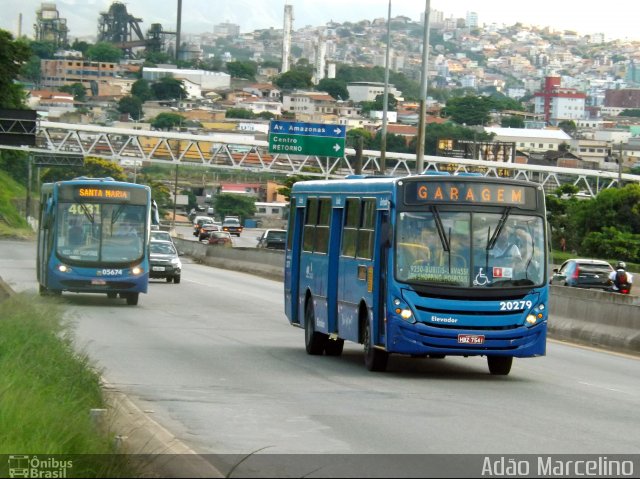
[174,238,640,354]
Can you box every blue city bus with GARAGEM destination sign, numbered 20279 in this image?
[284,174,549,375]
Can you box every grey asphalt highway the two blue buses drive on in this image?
[0,240,640,476]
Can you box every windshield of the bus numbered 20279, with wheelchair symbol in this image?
[395,211,545,288]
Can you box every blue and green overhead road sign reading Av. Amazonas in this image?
[269,120,346,158]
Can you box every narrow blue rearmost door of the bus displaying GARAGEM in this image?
[284,198,305,324]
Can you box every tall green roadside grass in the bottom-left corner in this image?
[0,294,138,477]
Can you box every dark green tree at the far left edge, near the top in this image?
[0,30,31,108]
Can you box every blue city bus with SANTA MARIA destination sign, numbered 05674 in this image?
[37,177,152,305]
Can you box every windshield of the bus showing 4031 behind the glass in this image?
[57,202,146,263]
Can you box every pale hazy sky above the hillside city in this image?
[0,0,640,41]
